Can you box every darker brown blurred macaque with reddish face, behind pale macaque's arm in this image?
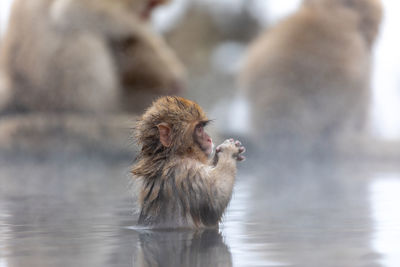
[109,0,187,107]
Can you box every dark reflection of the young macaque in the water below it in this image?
[133,230,232,267]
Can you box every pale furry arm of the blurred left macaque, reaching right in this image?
[50,0,149,38]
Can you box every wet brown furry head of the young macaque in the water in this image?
[136,96,213,162]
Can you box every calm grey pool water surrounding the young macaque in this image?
[0,158,400,267]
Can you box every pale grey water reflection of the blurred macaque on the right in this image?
[223,164,379,267]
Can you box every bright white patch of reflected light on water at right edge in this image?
[370,175,400,267]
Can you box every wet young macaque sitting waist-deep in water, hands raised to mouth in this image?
[132,97,245,228]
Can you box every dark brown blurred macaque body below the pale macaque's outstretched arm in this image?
[110,30,186,105]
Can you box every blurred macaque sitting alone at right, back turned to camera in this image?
[240,0,382,155]
